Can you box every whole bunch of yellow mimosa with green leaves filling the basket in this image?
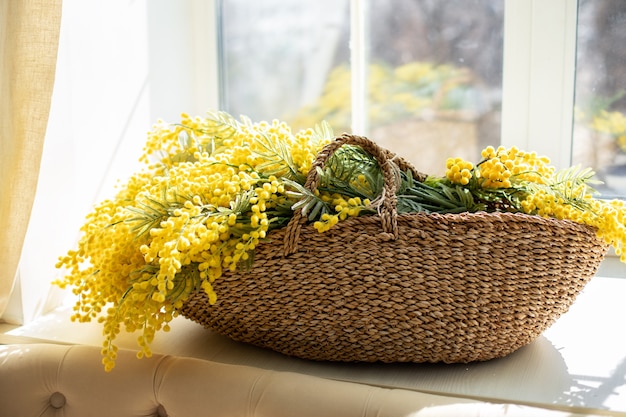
[57,112,626,370]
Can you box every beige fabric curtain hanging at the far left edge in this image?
[0,0,61,317]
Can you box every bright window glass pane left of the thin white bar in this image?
[220,0,350,125]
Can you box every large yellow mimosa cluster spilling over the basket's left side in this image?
[57,114,331,370]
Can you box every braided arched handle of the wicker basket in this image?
[283,133,426,255]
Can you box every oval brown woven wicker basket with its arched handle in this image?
[180,135,607,363]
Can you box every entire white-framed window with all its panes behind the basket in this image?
[218,0,626,187]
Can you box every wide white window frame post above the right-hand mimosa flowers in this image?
[501,0,578,168]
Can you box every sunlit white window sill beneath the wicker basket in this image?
[0,277,626,416]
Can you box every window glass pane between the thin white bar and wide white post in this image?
[369,0,504,175]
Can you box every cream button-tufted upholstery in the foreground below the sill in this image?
[0,344,596,417]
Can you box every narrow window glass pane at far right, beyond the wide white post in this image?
[572,0,626,198]
